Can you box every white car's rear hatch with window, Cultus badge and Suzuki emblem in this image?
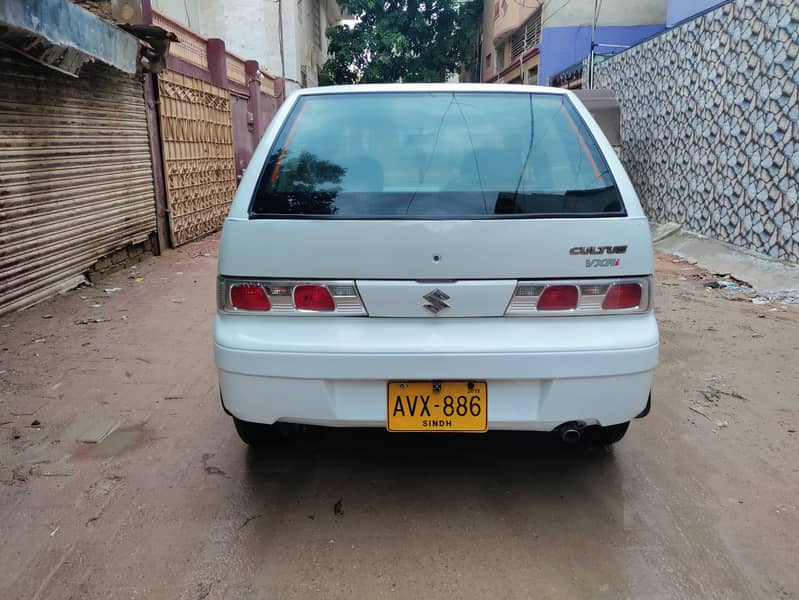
[219,92,653,318]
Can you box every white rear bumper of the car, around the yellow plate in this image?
[215,314,658,431]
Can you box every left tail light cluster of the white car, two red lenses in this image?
[217,277,367,316]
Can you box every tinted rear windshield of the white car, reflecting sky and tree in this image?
[250,92,625,219]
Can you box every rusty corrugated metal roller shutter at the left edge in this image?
[0,50,156,314]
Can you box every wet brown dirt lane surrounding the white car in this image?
[0,240,799,600]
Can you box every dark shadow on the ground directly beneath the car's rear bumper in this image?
[238,428,623,528]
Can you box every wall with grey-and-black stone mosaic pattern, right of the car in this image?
[595,0,799,262]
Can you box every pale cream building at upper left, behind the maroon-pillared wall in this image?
[153,0,341,92]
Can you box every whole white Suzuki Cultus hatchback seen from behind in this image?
[215,84,658,445]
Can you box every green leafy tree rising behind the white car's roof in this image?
[321,0,472,83]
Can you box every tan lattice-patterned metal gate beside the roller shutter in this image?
[158,72,236,246]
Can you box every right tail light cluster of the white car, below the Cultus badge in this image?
[505,277,652,316]
